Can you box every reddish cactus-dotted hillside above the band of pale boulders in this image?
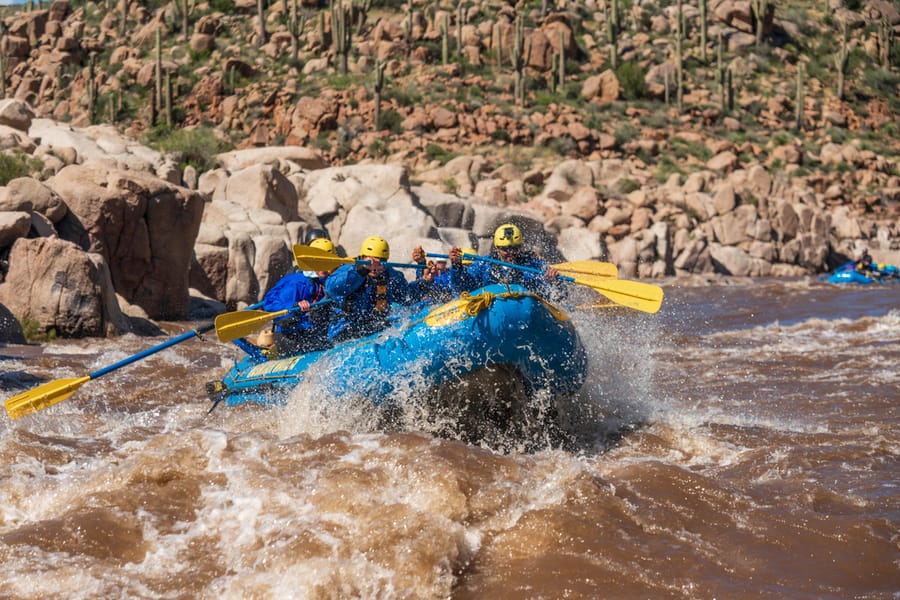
[0,0,900,169]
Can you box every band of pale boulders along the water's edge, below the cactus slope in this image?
[0,100,900,337]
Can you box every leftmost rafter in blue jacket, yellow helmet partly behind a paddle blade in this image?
[263,237,336,356]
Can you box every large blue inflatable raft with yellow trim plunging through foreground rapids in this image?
[207,285,587,406]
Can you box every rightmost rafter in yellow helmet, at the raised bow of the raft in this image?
[450,223,559,298]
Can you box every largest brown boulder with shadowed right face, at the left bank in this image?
[46,162,203,319]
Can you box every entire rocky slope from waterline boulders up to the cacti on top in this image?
[0,0,900,335]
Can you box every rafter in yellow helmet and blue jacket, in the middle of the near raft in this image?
[325,236,432,343]
